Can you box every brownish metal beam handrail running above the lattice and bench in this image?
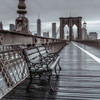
[0,30,66,45]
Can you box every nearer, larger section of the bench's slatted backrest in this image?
[24,47,41,64]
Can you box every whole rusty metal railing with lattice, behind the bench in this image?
[0,31,66,98]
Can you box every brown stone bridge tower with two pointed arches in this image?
[60,17,82,41]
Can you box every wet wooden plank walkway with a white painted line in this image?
[2,43,100,100]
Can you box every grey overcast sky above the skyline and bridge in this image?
[0,0,100,38]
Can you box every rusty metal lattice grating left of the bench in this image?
[0,45,29,97]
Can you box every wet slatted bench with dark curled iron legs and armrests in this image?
[23,46,61,92]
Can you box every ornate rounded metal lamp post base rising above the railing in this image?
[15,0,29,34]
